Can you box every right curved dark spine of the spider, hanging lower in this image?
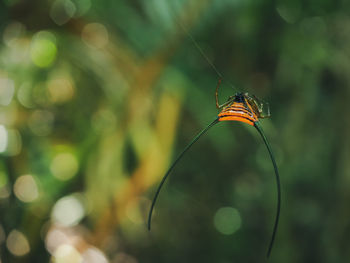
[254,121,281,257]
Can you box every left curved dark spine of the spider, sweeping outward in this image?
[148,118,219,230]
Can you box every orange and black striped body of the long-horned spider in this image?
[218,94,259,126]
